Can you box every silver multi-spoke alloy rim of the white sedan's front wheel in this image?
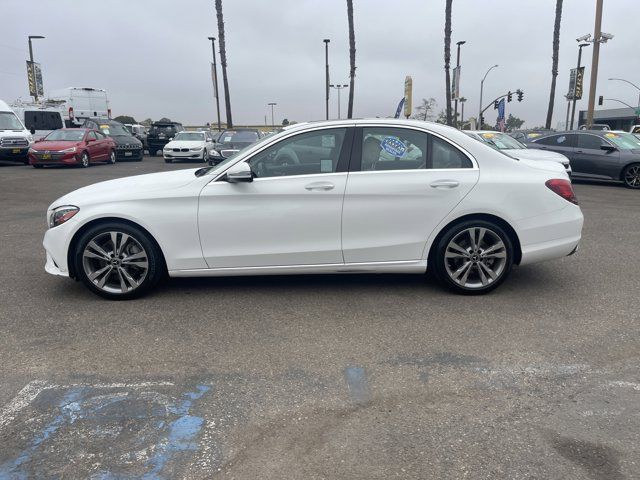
[82,231,149,294]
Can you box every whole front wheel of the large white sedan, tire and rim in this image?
[74,222,166,300]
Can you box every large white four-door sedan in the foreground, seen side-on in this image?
[44,119,583,299]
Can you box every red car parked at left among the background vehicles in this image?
[29,128,116,168]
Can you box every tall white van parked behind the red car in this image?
[49,87,111,127]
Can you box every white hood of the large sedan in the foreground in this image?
[50,168,198,208]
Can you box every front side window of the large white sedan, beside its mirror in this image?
[249,128,346,178]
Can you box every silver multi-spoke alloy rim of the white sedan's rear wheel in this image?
[444,227,507,290]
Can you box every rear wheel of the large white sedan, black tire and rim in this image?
[428,220,514,295]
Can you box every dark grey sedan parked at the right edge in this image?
[530,130,640,188]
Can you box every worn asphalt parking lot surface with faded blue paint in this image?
[0,157,640,479]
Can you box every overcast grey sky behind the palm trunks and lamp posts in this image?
[0,0,640,127]
